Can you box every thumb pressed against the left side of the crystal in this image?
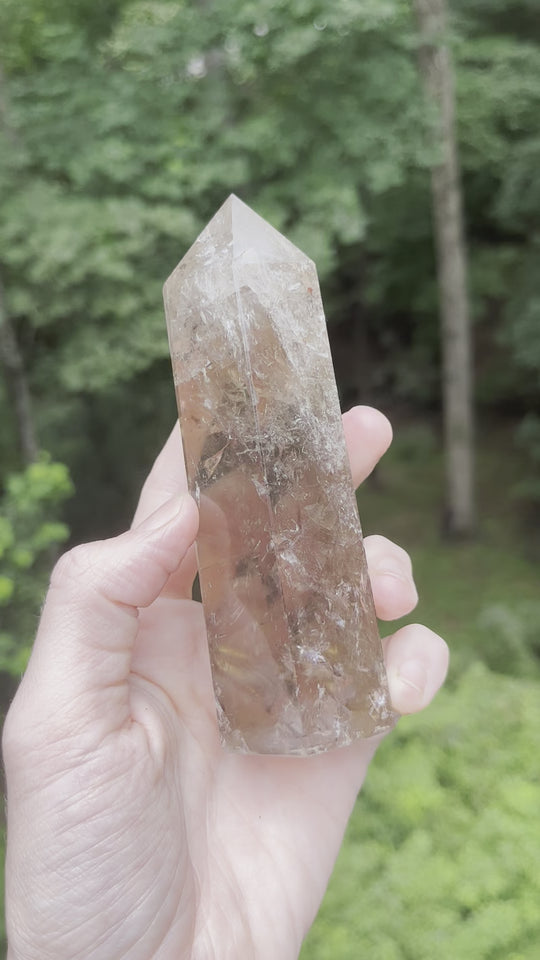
[16,494,198,730]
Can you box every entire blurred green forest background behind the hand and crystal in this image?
[0,0,540,960]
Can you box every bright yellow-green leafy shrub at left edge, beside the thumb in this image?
[0,454,73,676]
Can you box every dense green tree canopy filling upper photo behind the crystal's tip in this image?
[0,0,540,513]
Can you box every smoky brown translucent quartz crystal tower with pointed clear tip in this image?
[164,196,395,755]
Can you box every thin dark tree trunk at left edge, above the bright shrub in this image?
[0,278,38,463]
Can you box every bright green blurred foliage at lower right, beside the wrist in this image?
[302,665,540,960]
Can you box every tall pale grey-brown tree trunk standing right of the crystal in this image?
[413,0,475,536]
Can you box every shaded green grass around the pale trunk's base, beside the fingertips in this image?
[359,424,540,680]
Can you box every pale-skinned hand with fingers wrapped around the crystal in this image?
[4,407,448,960]
